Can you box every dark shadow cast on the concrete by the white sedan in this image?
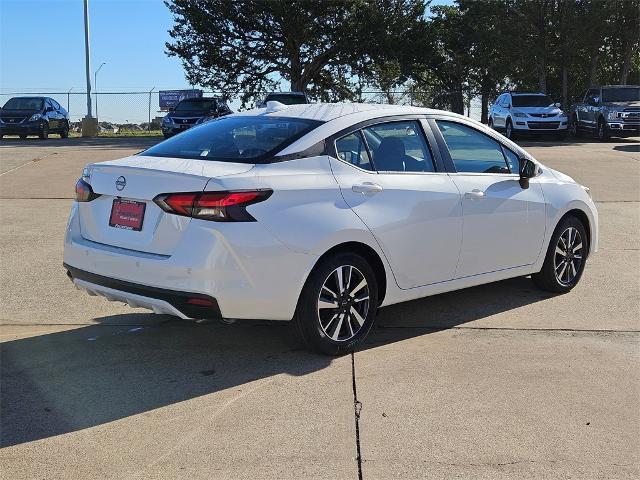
[0,279,549,447]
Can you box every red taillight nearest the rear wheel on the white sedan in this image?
[158,190,273,222]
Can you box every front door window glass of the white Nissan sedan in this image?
[436,120,510,173]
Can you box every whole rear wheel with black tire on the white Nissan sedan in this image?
[292,253,378,355]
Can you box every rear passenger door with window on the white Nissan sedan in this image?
[331,120,462,288]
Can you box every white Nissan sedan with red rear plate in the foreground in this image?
[64,102,598,354]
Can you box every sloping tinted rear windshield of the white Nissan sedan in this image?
[141,116,322,163]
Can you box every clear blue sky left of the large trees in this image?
[0,0,452,122]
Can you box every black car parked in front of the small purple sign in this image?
[162,97,232,138]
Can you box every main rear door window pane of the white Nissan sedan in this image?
[363,120,435,172]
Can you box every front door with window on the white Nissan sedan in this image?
[435,119,546,278]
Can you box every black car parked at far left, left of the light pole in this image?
[0,97,69,138]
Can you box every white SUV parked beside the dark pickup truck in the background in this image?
[489,92,568,138]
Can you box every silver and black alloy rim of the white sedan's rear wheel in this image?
[318,265,369,342]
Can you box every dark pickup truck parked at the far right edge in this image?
[569,85,640,141]
